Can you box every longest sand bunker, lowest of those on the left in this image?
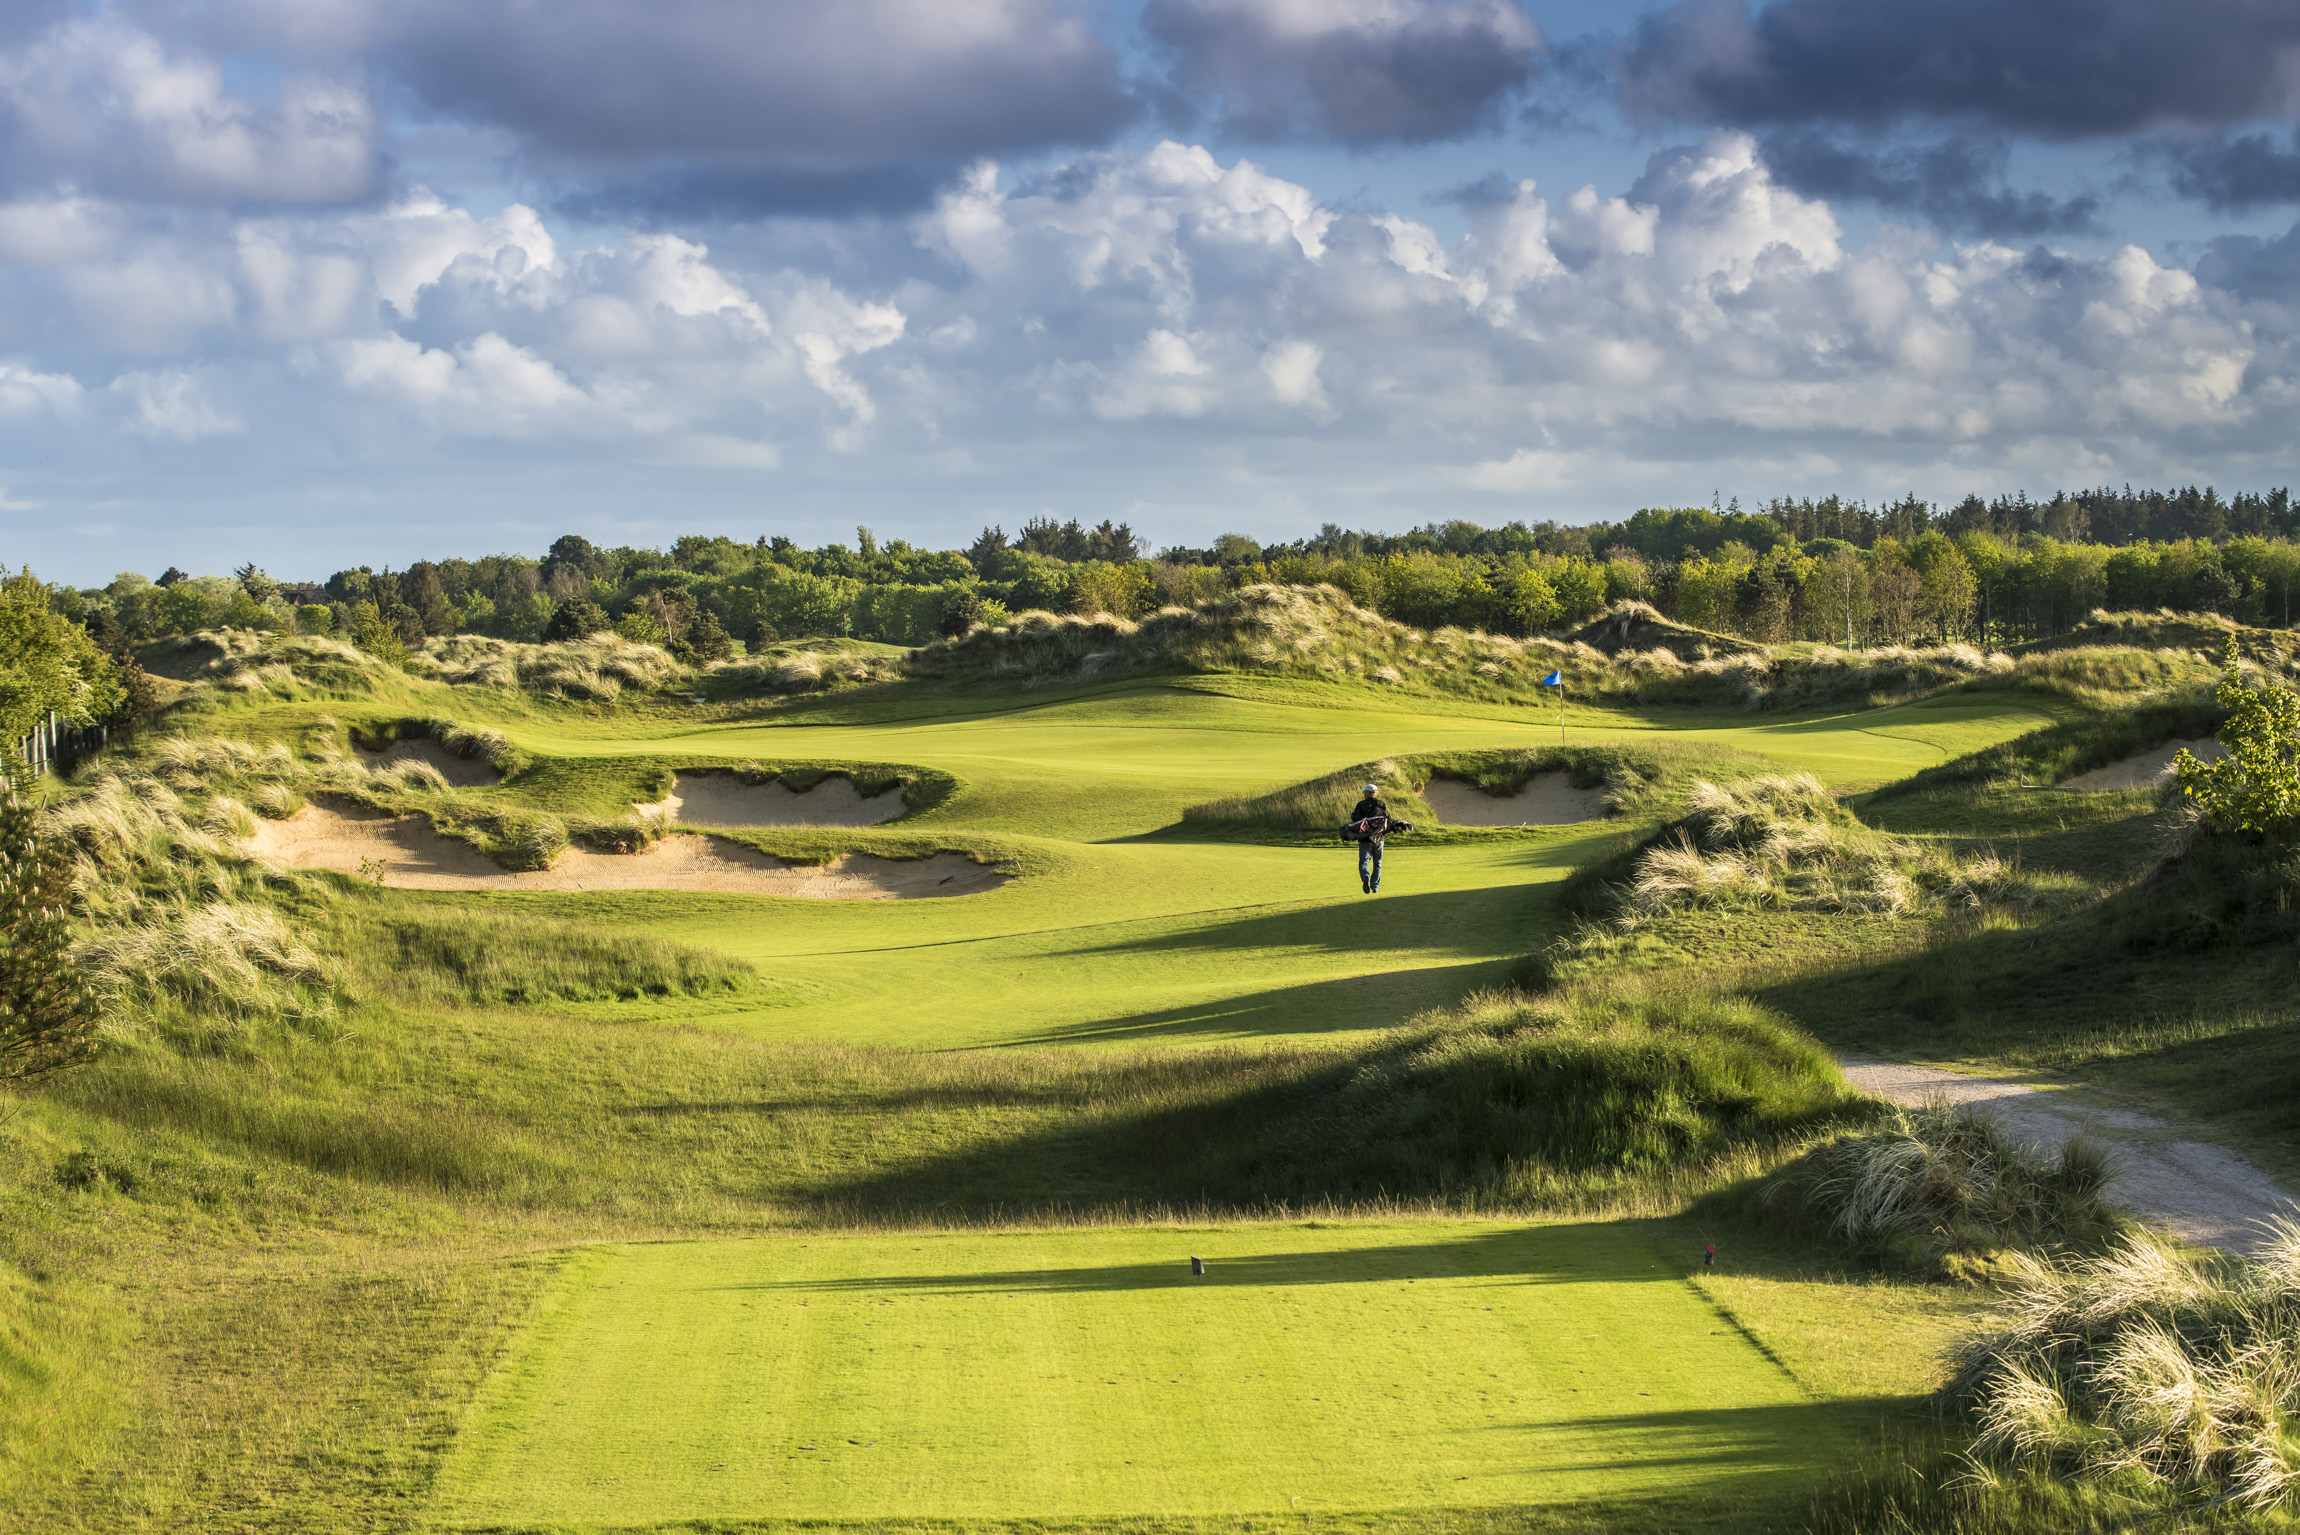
[251,805,1007,900]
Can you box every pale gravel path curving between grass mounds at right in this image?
[1845,1061,2300,1252]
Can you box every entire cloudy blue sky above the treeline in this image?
[13,0,2300,585]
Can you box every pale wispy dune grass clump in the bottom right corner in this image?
[1950,1222,2300,1510]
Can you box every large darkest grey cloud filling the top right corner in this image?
[1619,0,2300,138]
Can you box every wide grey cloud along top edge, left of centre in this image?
[377,0,1136,170]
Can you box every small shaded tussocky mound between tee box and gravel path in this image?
[1762,1102,2111,1268]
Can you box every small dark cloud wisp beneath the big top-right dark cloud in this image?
[1762,129,2100,239]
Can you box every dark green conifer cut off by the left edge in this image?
[0,769,99,1082]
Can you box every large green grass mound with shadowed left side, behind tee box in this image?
[823,985,1872,1217]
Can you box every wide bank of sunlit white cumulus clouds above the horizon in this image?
[13,131,2300,575]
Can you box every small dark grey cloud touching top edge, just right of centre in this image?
[1143,0,1541,147]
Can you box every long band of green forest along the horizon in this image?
[27,488,2300,681]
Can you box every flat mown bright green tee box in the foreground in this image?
[435,1222,1854,1528]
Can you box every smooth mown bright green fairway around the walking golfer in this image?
[471,679,2049,1049]
